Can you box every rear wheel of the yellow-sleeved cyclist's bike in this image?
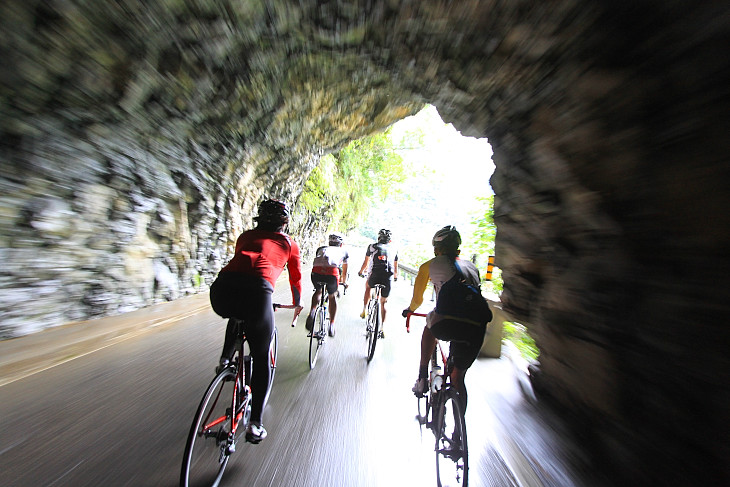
[434,389,469,487]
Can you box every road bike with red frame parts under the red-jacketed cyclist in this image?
[180,304,296,487]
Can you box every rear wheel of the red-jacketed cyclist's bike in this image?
[180,367,237,487]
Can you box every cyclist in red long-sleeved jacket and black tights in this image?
[210,199,302,443]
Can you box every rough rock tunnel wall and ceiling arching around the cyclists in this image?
[0,0,730,485]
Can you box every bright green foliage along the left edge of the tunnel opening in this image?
[299,130,406,232]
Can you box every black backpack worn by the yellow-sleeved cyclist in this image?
[436,260,492,325]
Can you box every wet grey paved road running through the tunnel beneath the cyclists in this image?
[0,277,578,487]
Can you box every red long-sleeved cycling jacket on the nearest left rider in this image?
[221,230,302,305]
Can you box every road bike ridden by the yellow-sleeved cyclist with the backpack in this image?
[406,313,469,487]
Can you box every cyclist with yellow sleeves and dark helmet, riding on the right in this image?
[403,225,491,410]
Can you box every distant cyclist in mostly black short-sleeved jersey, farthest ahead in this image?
[357,228,398,338]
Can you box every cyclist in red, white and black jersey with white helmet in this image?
[305,233,350,336]
